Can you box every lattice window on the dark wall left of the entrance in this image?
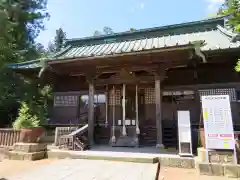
[54,95,78,107]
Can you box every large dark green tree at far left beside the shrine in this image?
[0,0,49,126]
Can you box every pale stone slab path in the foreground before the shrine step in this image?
[6,159,157,180]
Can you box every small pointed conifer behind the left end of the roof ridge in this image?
[48,28,67,53]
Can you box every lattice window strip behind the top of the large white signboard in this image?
[198,88,237,101]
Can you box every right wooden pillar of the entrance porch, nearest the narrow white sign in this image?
[155,75,164,148]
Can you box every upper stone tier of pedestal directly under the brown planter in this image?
[13,143,47,153]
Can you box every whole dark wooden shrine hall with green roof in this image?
[9,18,240,150]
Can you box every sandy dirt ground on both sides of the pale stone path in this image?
[0,159,234,180]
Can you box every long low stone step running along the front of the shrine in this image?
[48,149,195,169]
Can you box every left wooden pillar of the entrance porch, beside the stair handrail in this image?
[88,80,94,145]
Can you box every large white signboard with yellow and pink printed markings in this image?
[202,95,236,164]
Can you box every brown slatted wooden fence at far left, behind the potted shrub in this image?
[0,129,20,147]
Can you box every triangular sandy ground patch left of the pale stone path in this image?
[0,159,54,177]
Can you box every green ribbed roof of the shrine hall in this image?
[9,18,240,68]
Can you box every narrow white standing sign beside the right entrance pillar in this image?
[178,111,192,156]
